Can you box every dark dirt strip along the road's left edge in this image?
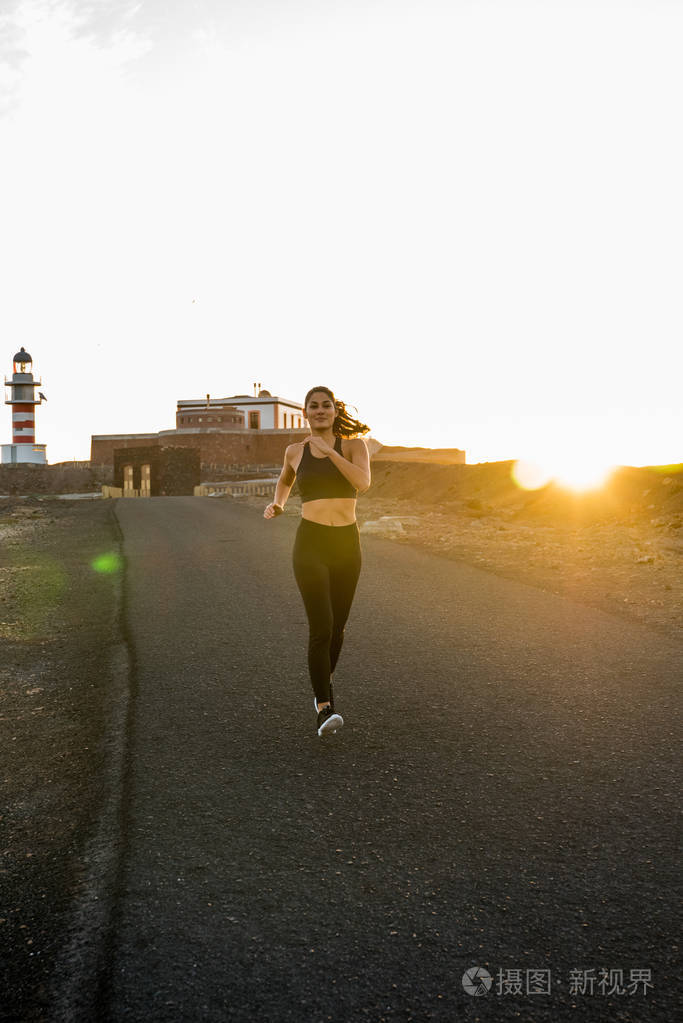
[0,498,120,1020]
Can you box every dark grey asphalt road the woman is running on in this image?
[101,498,682,1023]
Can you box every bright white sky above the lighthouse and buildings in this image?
[0,0,683,464]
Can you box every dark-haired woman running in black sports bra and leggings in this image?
[264,387,370,738]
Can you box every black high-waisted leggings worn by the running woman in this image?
[291,519,361,703]
